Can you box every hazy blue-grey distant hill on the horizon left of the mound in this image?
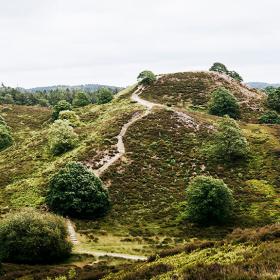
[18,84,123,92]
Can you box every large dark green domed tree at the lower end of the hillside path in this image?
[46,162,110,218]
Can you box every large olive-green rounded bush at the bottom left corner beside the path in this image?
[0,210,72,263]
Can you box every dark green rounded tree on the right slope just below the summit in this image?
[208,88,240,118]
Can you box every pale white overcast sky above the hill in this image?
[0,0,280,87]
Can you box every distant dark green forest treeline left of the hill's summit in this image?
[0,84,121,107]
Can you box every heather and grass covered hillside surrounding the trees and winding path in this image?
[0,72,280,280]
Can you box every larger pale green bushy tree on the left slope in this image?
[49,120,78,155]
